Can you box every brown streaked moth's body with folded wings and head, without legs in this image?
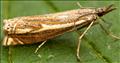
[3,5,115,46]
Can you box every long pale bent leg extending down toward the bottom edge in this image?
[76,21,94,61]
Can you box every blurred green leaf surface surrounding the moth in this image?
[0,1,120,63]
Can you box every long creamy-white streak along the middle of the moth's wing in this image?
[32,20,86,33]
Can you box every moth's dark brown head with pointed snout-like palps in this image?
[96,4,116,16]
